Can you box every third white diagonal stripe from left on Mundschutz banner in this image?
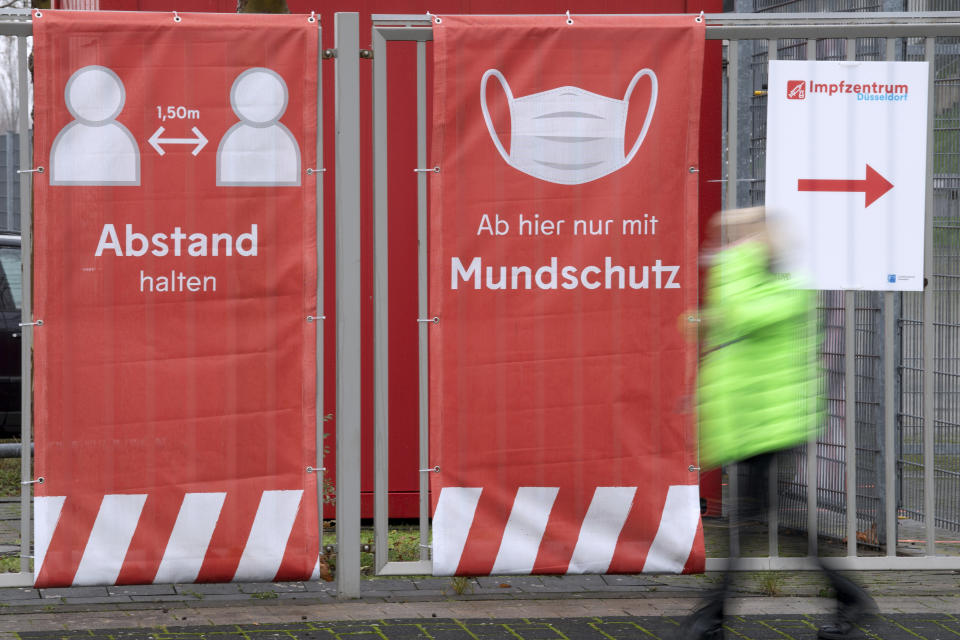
[567,487,637,573]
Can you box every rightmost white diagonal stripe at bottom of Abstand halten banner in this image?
[233,489,303,582]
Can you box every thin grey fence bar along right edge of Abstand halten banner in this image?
[314,18,327,568]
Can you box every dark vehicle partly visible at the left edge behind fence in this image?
[0,233,23,438]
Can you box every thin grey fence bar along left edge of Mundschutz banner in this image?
[417,41,430,560]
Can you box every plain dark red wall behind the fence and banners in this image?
[100,0,722,518]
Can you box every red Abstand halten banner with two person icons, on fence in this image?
[33,11,319,587]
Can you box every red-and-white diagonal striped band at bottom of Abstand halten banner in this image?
[34,490,319,586]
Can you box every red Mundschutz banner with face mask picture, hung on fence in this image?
[429,16,704,575]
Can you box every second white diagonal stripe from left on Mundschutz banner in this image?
[490,487,560,574]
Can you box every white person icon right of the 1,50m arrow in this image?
[217,67,300,187]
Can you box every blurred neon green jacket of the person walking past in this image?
[699,240,823,468]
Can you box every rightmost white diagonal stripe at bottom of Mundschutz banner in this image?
[643,484,700,573]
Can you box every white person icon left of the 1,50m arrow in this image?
[50,65,140,186]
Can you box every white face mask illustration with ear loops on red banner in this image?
[480,69,657,184]
